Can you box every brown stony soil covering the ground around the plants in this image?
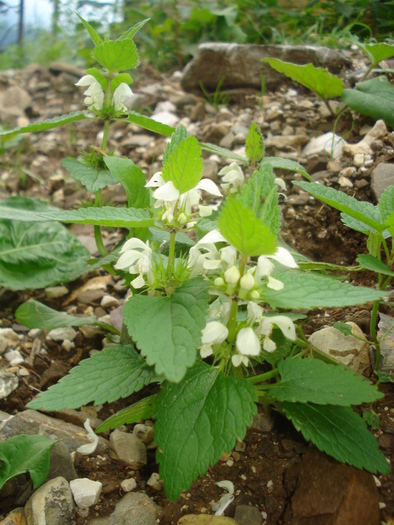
[0,46,394,525]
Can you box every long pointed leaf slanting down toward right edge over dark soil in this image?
[293,182,386,232]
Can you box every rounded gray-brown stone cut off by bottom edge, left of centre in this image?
[88,492,163,525]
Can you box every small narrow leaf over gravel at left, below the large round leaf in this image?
[15,299,100,330]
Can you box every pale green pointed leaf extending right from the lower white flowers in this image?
[263,266,387,310]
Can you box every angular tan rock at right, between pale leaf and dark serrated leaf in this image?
[309,322,371,376]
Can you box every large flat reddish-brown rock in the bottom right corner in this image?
[291,449,380,525]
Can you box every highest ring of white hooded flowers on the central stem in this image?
[146,172,222,222]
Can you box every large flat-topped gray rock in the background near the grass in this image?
[181,42,351,92]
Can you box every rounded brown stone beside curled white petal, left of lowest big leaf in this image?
[109,429,147,470]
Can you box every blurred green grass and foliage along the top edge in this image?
[0,0,394,70]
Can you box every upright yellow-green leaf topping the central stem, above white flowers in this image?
[161,135,204,194]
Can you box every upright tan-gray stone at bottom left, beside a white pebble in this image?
[25,476,76,525]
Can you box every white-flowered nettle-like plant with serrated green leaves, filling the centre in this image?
[0,19,391,499]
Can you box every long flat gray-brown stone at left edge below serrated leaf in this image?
[0,410,107,454]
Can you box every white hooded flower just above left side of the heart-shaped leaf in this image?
[114,237,153,288]
